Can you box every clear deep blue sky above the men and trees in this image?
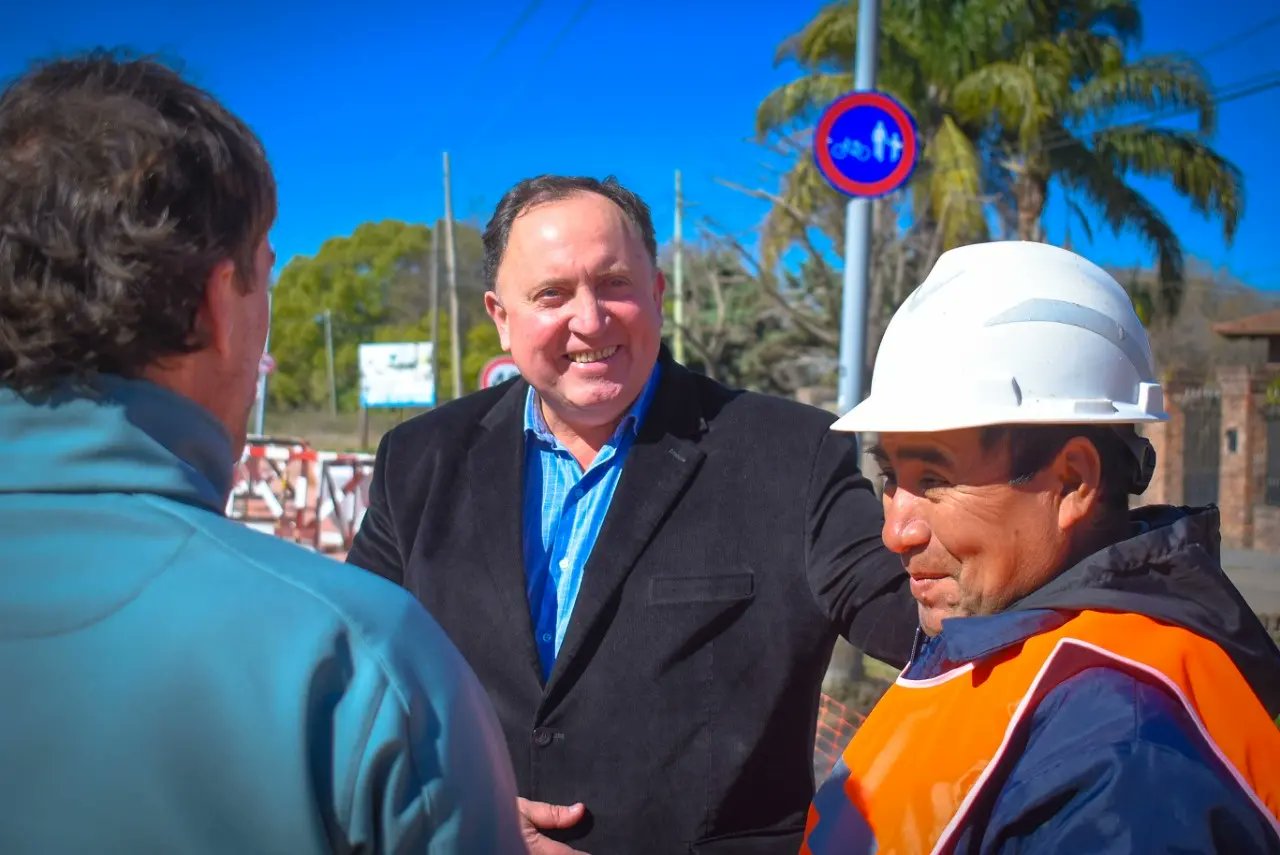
[0,0,1280,291]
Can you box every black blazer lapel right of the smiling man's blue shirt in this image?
[544,360,705,699]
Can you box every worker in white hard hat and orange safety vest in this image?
[804,243,1280,855]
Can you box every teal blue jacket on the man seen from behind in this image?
[0,378,525,855]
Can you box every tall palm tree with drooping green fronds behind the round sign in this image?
[756,0,1243,317]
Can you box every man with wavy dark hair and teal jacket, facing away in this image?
[0,52,524,852]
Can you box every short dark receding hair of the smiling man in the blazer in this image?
[484,175,658,289]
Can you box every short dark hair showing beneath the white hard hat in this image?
[979,425,1139,516]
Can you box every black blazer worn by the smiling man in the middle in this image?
[348,355,916,855]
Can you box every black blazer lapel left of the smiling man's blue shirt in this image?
[467,381,541,681]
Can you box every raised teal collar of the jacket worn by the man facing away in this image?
[0,375,236,512]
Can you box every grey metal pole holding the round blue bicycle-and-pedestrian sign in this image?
[836,0,879,413]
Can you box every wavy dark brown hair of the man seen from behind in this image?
[0,51,275,392]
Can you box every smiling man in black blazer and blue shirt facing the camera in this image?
[349,175,916,854]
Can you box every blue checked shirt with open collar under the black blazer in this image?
[525,366,658,681]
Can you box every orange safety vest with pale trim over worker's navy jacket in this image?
[800,612,1280,855]
